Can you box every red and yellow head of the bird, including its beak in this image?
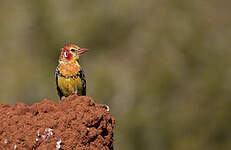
[60,44,88,61]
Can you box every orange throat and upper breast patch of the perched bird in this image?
[59,62,80,76]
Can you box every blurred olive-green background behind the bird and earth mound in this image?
[0,0,231,150]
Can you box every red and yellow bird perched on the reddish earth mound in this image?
[55,44,88,100]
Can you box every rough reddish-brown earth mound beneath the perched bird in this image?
[0,95,115,150]
